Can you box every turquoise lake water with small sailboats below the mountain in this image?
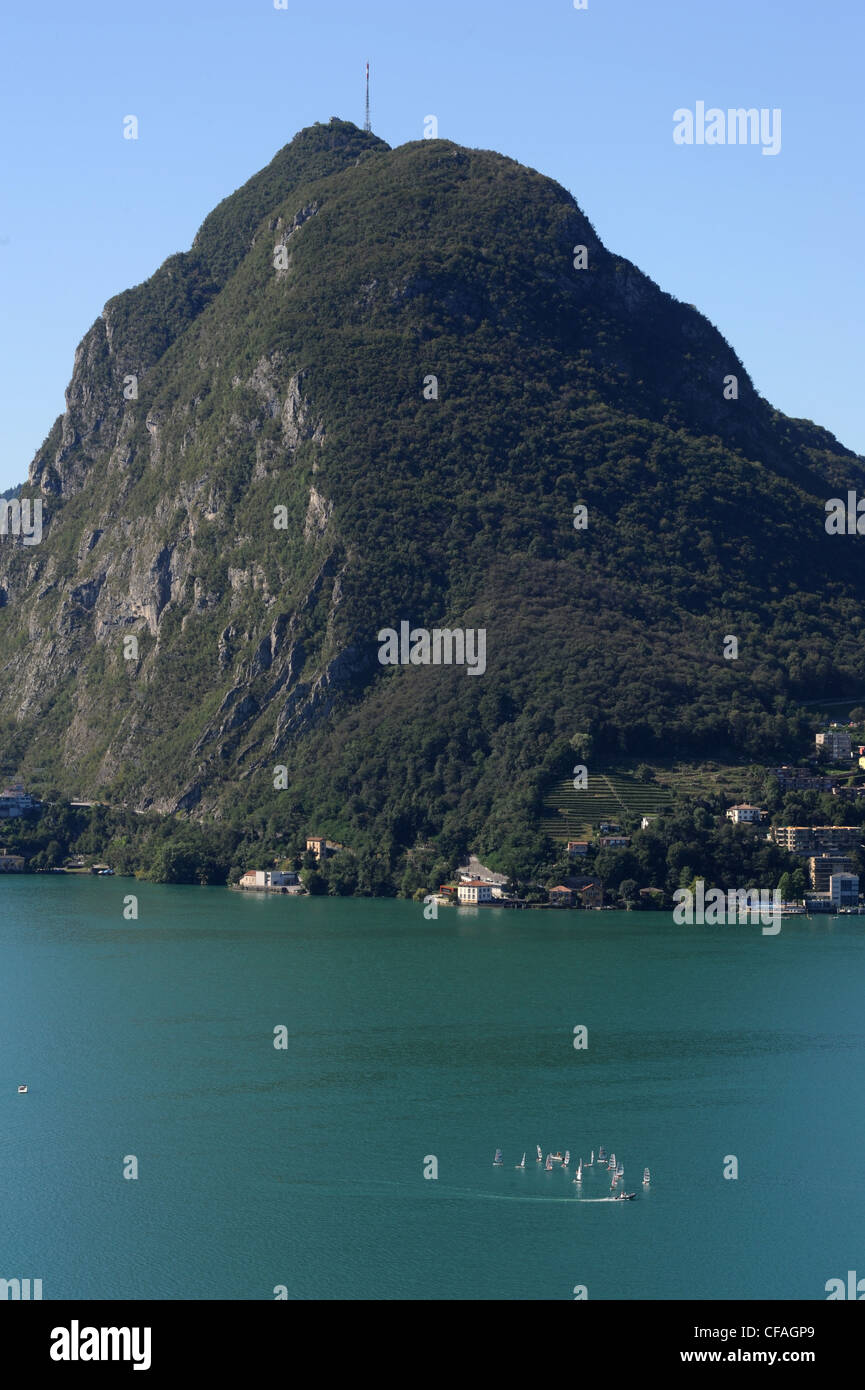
[0,876,865,1301]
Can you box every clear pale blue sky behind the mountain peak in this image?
[0,0,865,488]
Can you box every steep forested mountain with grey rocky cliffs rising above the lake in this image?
[0,120,865,858]
